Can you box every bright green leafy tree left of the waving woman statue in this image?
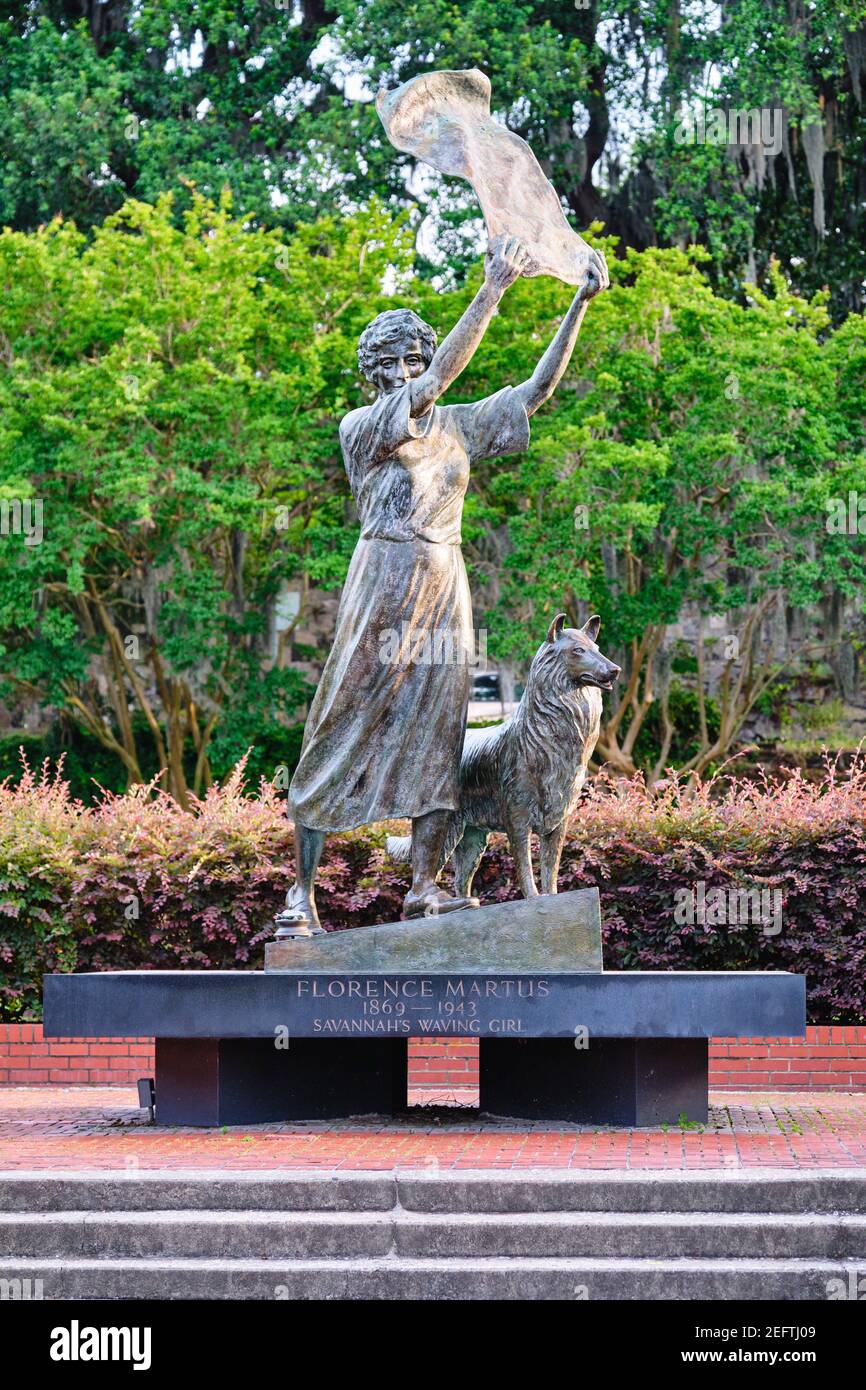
[0,197,410,802]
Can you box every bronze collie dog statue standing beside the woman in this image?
[388,613,620,898]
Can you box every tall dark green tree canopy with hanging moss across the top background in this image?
[0,0,866,321]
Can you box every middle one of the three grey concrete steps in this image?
[0,1208,866,1272]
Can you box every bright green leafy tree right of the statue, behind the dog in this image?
[422,229,866,774]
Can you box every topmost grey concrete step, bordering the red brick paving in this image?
[6,1169,866,1215]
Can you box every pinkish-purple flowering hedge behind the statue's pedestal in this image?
[0,759,866,1023]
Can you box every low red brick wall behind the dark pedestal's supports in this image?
[0,1023,866,1091]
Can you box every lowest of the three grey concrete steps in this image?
[0,1257,863,1301]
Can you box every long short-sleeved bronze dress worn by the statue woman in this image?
[289,385,530,831]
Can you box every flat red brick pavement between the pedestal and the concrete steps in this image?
[0,1086,866,1172]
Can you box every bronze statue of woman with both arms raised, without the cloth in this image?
[277,236,607,935]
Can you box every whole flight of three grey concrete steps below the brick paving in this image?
[0,1170,866,1301]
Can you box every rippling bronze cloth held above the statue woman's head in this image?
[375,68,589,285]
